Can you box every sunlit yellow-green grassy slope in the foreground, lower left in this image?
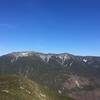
[0,76,73,100]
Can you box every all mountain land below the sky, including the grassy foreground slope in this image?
[0,51,100,100]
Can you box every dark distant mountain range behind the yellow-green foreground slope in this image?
[0,52,100,100]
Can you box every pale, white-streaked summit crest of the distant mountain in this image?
[10,51,70,62]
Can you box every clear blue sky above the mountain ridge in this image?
[0,0,100,56]
